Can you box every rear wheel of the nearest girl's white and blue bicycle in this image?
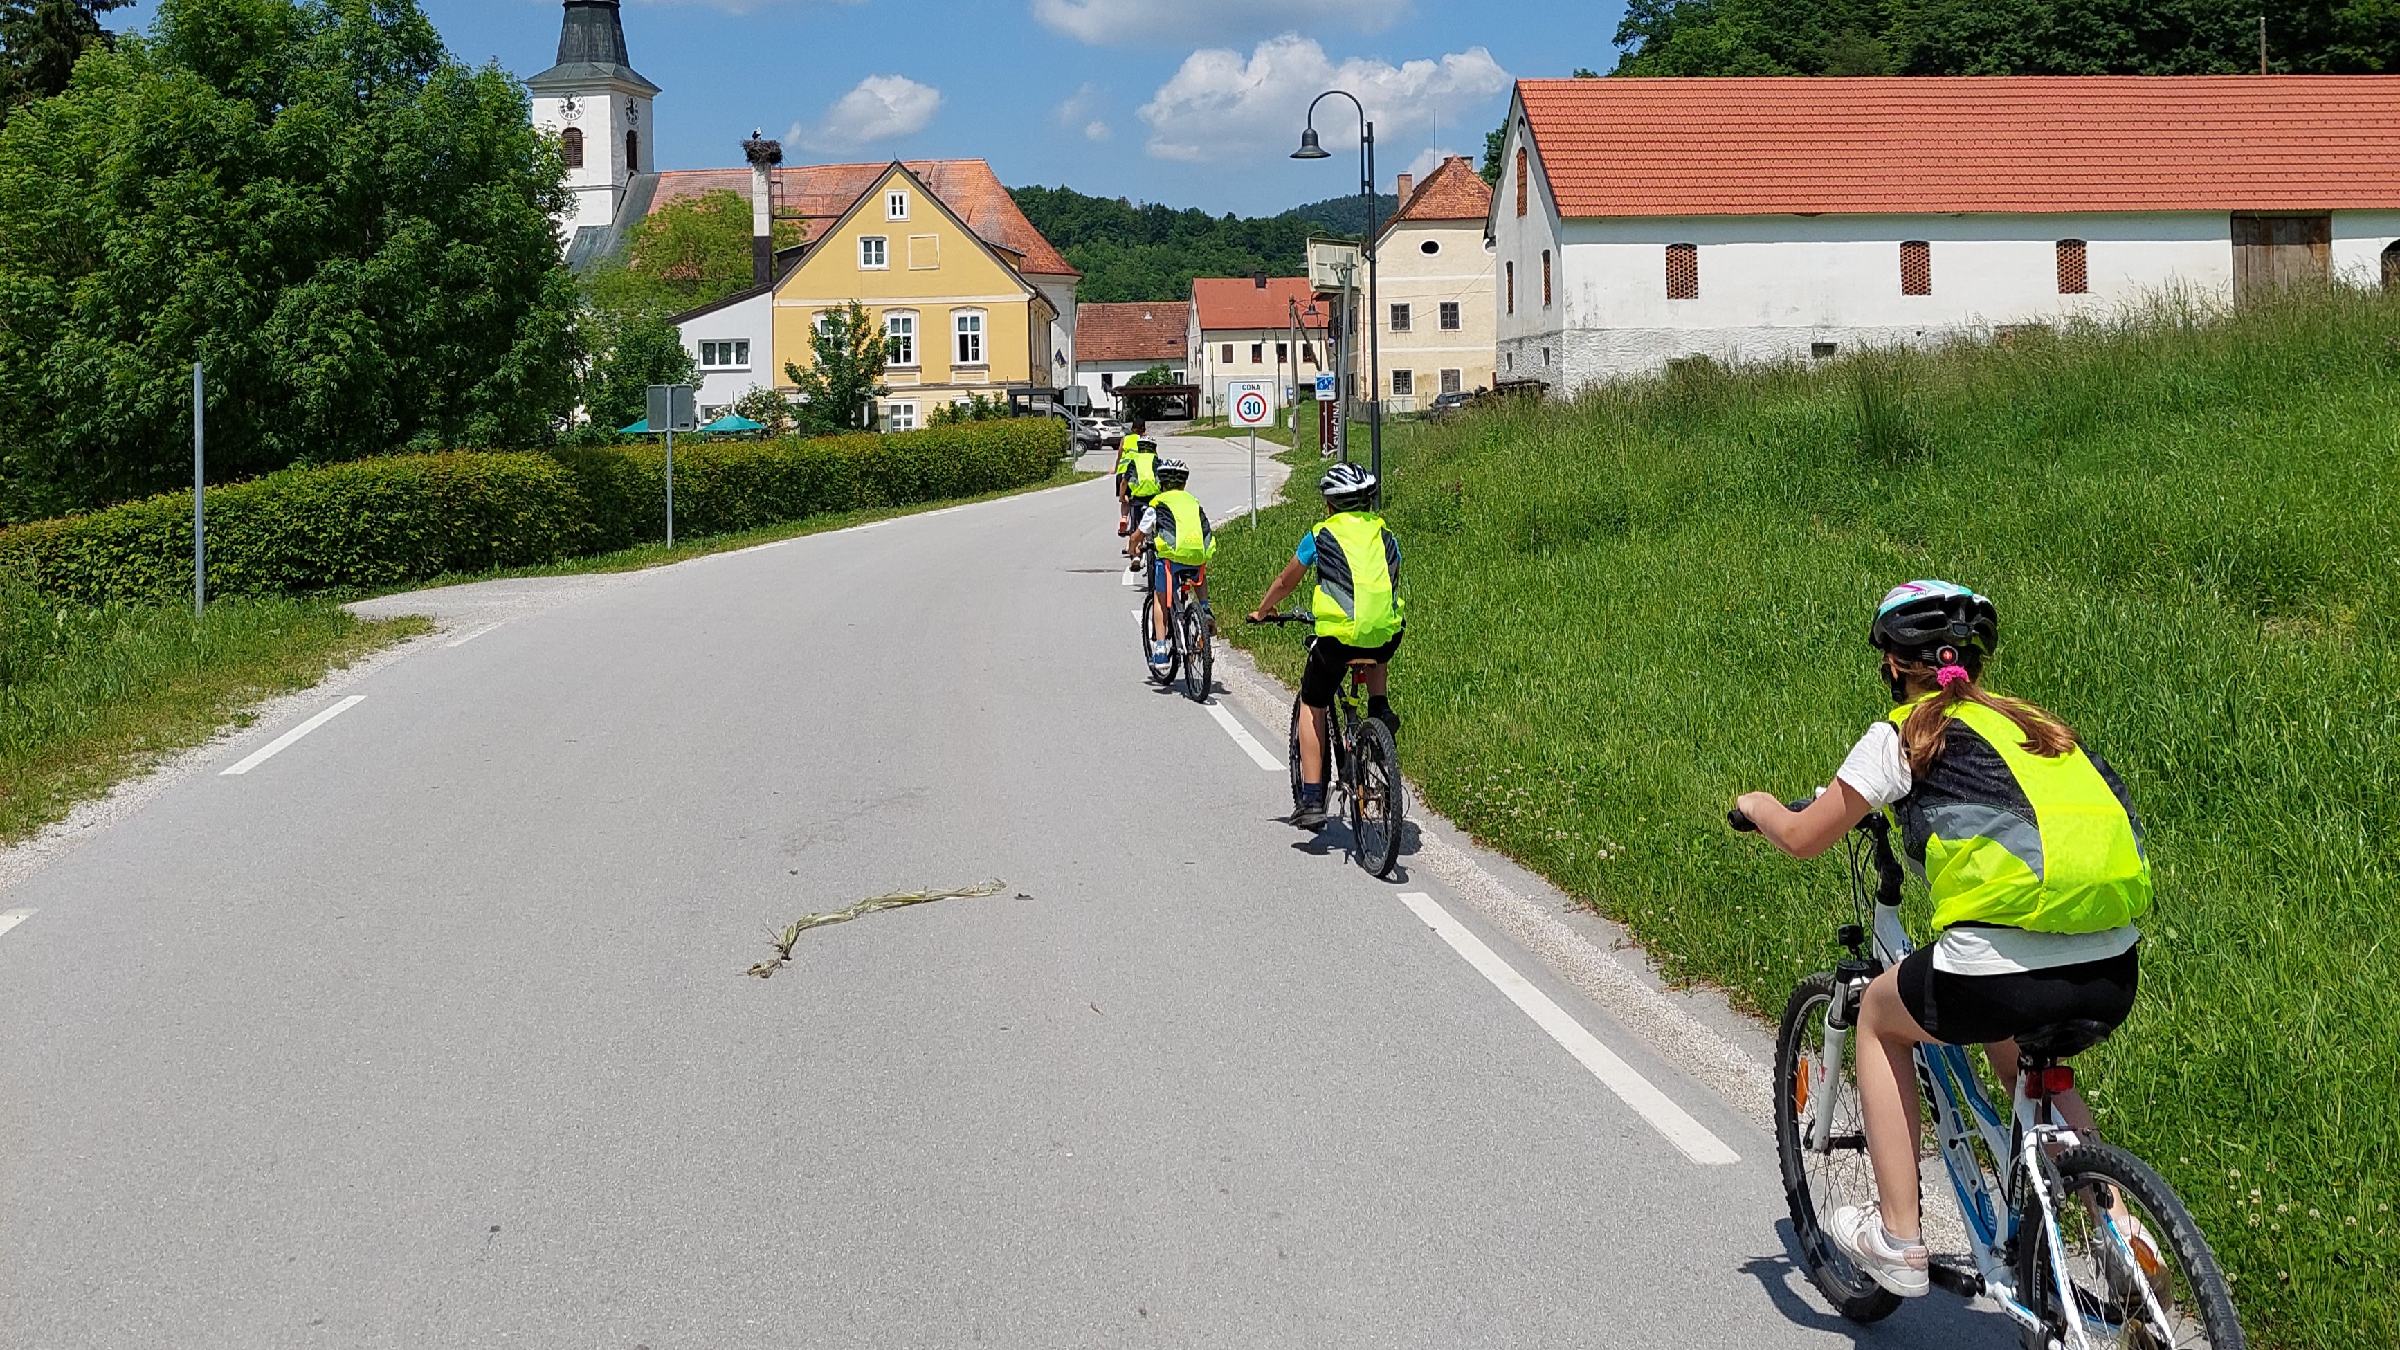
[2016,1143,2244,1350]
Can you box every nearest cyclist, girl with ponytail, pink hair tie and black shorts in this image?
[1735,581,2150,1295]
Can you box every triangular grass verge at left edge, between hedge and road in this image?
[0,593,430,843]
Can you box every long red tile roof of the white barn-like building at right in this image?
[1517,74,2400,216]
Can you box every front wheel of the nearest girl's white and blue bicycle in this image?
[1776,970,1901,1324]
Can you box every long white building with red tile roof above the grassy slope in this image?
[1486,77,2400,392]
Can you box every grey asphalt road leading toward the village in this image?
[0,440,2004,1350]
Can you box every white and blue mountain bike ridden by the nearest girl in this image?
[1728,802,2244,1350]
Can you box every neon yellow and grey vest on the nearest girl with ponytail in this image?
[1891,699,2150,932]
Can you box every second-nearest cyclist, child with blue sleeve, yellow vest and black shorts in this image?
[1250,464,1404,829]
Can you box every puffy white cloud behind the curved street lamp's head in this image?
[1142,34,1512,173]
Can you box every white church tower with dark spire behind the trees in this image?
[526,0,658,243]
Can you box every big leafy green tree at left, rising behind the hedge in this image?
[0,0,576,504]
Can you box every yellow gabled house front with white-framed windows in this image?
[773,163,1058,430]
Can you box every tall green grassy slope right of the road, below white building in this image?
[1217,295,2400,1350]
